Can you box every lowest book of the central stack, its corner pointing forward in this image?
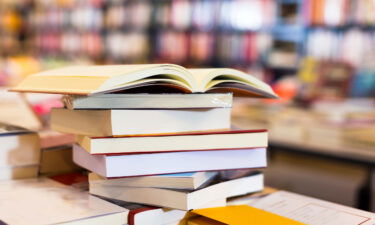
[90,173,263,210]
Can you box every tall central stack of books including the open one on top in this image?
[14,64,276,224]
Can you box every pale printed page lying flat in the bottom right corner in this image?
[250,191,375,225]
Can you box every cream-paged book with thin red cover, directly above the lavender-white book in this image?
[76,130,268,154]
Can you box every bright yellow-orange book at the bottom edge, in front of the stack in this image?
[188,205,303,225]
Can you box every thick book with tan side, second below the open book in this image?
[51,108,231,136]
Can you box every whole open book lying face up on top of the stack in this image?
[12,64,277,98]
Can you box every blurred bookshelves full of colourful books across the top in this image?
[0,0,375,98]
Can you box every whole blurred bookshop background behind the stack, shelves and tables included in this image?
[0,0,375,211]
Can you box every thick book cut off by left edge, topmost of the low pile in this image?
[0,122,40,168]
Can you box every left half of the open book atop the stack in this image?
[12,64,197,95]
